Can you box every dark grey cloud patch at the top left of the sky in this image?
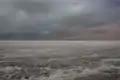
[13,1,50,14]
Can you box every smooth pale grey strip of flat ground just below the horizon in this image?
[0,41,120,57]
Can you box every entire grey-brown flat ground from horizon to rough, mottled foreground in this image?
[0,41,120,80]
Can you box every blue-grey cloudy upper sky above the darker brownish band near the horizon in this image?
[0,0,120,32]
